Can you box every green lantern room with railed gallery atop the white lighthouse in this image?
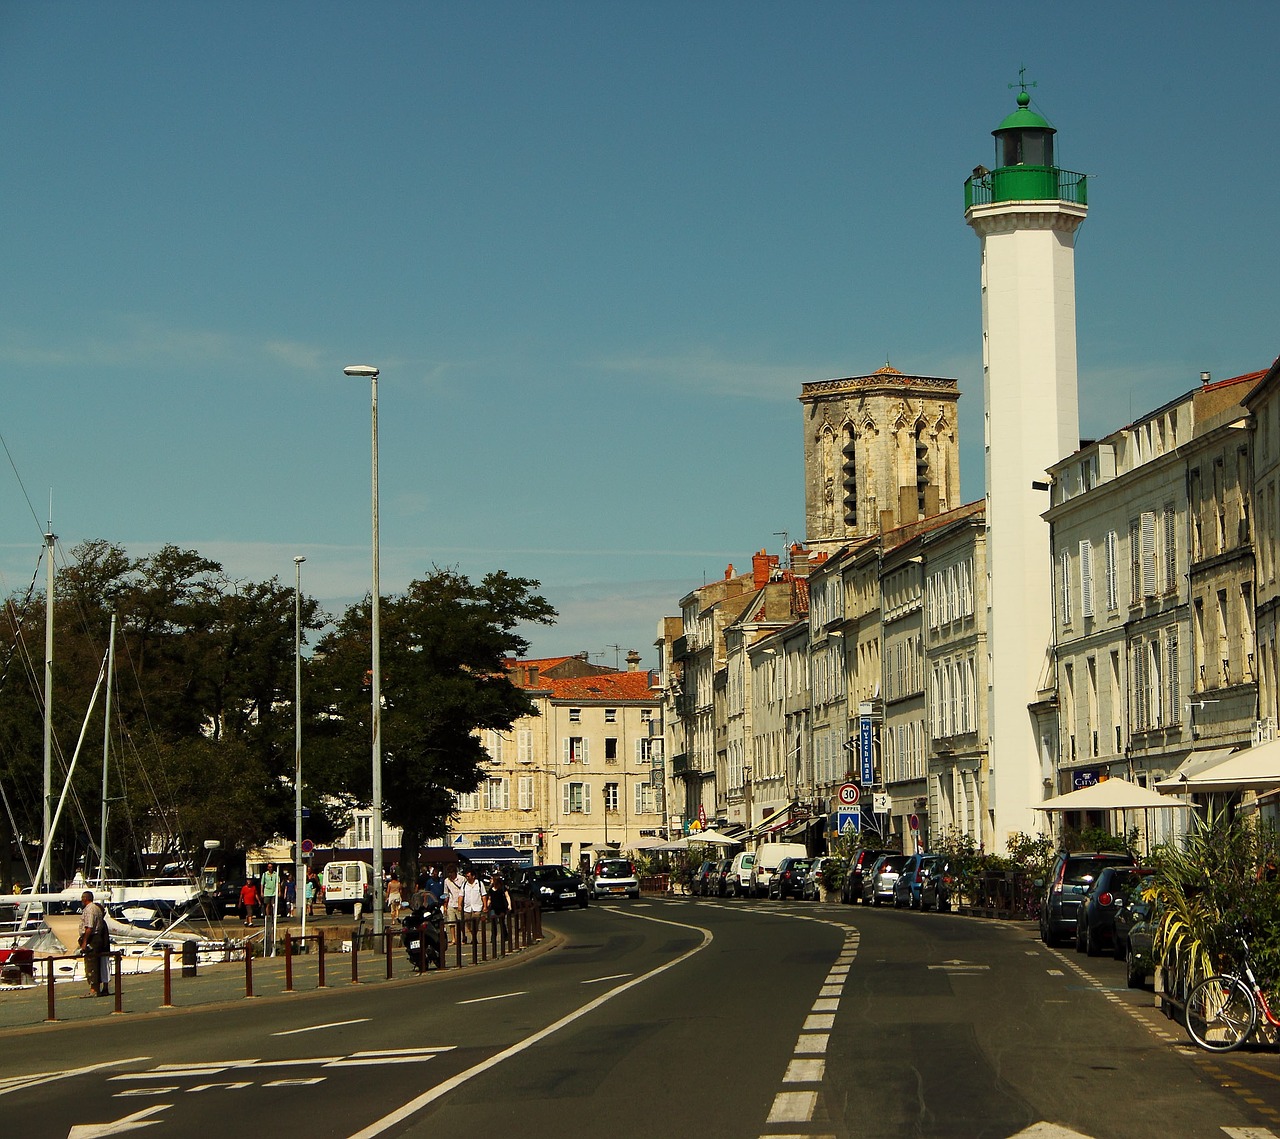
[964,83,1088,211]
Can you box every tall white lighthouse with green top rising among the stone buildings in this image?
[965,84,1088,850]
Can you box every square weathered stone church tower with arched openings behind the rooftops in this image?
[800,363,960,550]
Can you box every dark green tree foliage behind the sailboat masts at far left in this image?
[0,541,325,884]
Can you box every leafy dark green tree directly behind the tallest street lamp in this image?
[311,568,556,868]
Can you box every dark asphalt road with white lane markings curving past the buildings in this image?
[0,898,1280,1139]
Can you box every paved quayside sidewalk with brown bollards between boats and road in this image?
[0,920,559,1035]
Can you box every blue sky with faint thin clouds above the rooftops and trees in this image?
[0,0,1280,665]
